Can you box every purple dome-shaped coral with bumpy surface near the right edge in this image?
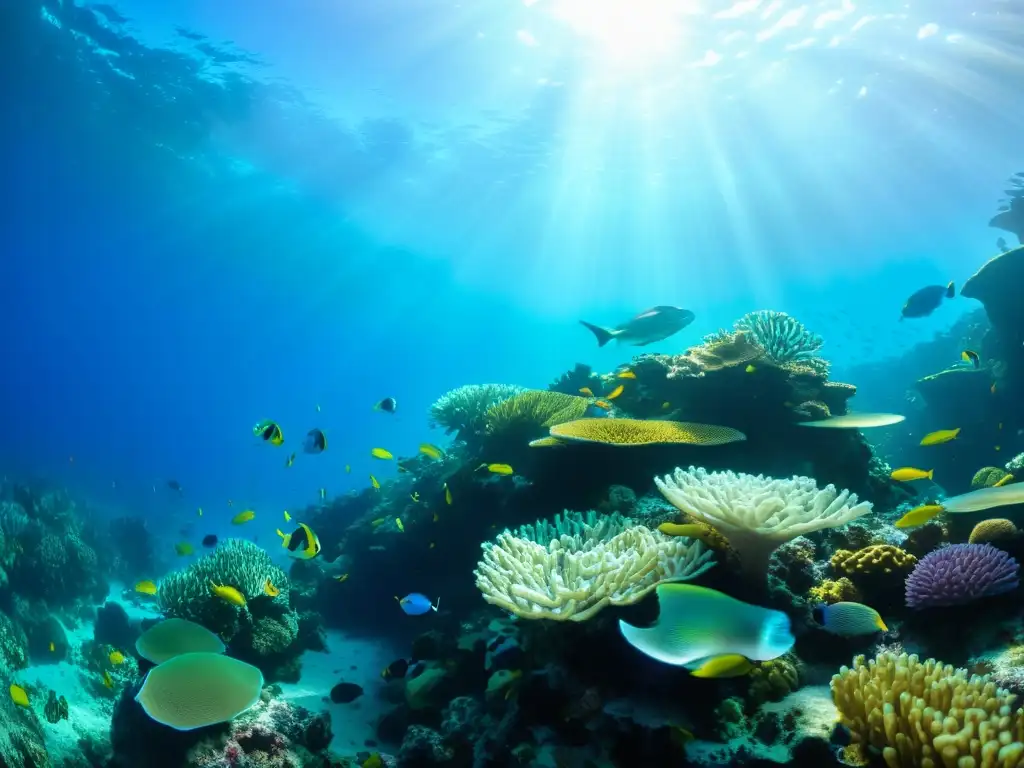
[906,544,1020,608]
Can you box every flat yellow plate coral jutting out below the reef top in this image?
[551,419,746,445]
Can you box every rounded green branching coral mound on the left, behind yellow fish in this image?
[159,539,290,642]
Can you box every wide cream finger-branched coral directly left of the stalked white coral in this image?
[474,518,715,622]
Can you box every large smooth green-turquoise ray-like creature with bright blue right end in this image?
[618,584,796,667]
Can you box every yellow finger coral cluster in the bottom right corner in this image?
[831,652,1024,768]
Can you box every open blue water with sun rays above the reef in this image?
[6,0,1024,765]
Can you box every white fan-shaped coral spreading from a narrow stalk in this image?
[654,467,871,574]
